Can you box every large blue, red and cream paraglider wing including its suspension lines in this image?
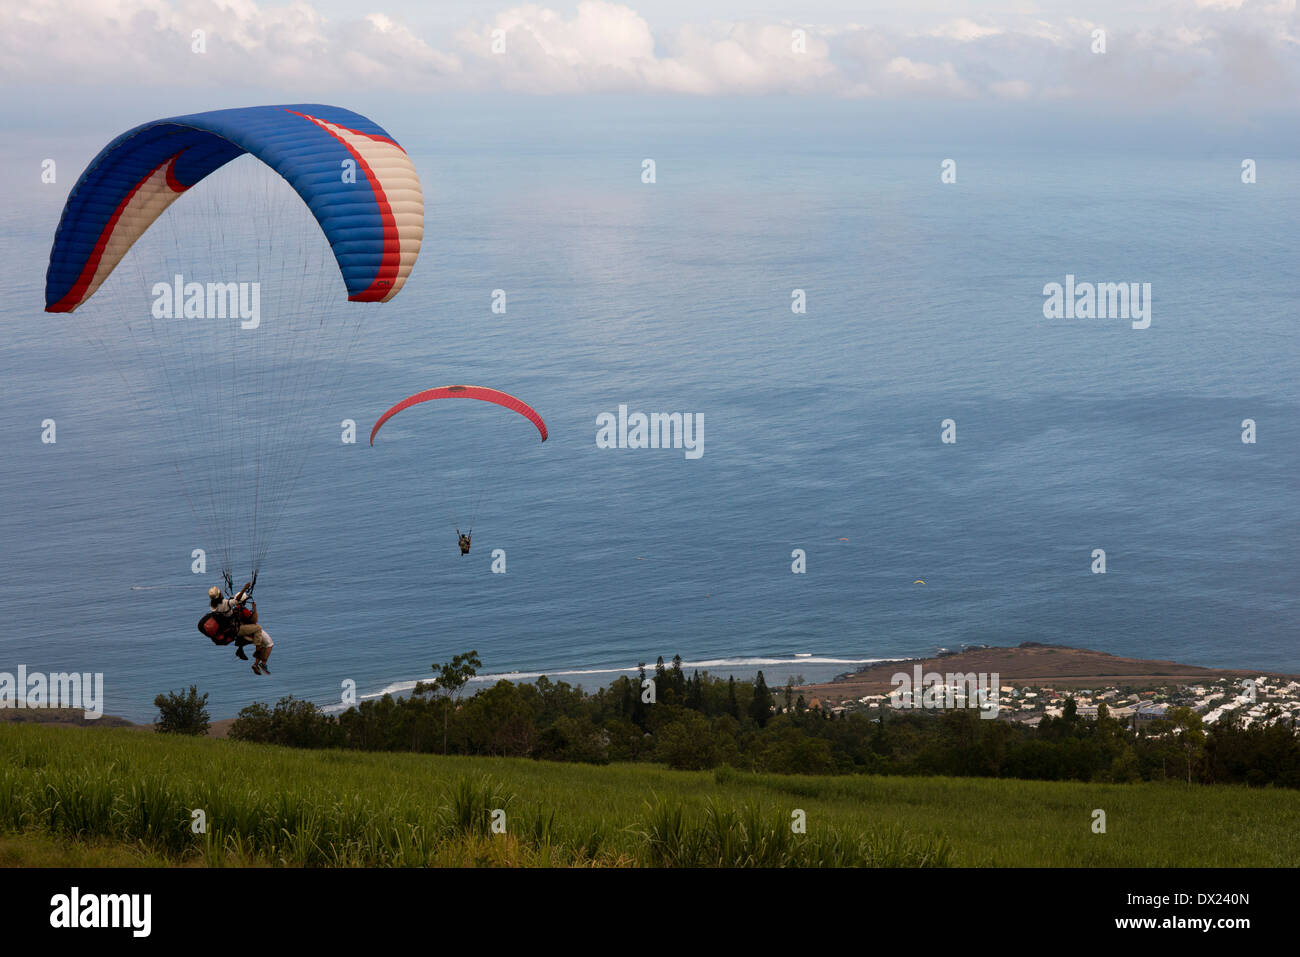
[46,104,424,584]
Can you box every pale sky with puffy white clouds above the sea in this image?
[0,0,1300,115]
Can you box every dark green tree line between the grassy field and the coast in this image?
[180,651,1300,788]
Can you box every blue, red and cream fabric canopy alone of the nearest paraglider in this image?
[46,104,424,312]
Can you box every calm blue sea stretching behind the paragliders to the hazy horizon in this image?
[0,98,1300,720]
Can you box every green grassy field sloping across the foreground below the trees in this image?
[0,724,1300,867]
